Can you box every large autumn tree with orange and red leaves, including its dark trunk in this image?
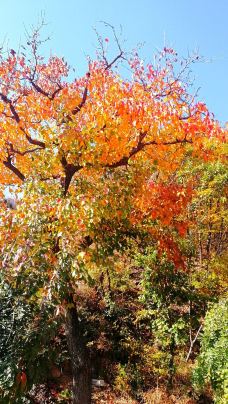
[0,23,224,404]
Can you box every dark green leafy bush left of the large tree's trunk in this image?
[0,274,67,403]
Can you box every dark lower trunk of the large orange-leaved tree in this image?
[65,301,91,404]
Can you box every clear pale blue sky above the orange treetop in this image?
[0,0,228,122]
